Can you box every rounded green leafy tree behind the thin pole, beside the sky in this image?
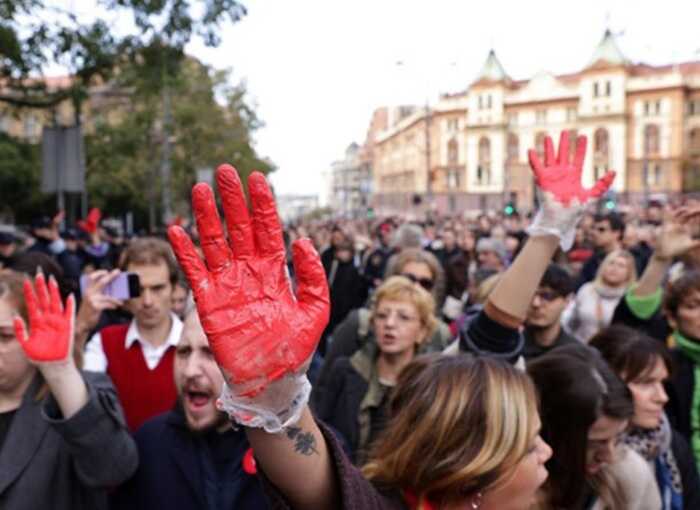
[86,58,274,229]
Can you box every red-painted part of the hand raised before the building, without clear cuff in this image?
[528,131,615,206]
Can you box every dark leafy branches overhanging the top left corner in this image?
[0,0,246,110]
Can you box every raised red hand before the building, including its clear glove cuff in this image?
[528,131,615,251]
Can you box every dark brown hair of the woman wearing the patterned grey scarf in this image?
[589,324,673,383]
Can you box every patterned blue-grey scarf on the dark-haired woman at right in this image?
[622,414,683,510]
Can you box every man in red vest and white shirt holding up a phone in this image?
[78,238,182,431]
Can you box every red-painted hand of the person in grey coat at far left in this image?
[14,273,75,363]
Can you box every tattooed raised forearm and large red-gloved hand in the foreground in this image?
[168,165,339,509]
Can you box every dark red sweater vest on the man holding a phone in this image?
[100,324,177,432]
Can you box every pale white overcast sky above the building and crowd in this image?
[50,0,700,193]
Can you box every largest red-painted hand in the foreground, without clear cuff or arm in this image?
[168,165,330,396]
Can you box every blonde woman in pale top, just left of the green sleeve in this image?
[562,250,637,342]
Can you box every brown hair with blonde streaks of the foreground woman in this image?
[363,354,537,505]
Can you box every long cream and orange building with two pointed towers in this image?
[373,31,700,214]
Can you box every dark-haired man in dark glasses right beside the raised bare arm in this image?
[522,264,578,361]
